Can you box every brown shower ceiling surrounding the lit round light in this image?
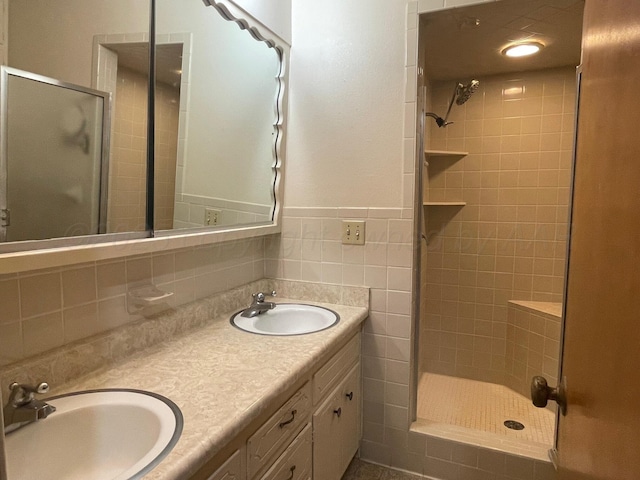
[420,0,584,81]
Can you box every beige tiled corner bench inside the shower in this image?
[505,301,562,397]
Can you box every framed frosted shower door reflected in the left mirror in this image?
[0,67,110,241]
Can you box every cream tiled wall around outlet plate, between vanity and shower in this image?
[266,208,413,468]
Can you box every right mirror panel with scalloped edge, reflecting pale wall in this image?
[155,0,282,229]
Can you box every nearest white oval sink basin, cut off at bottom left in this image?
[5,390,182,480]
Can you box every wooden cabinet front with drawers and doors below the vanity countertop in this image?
[192,332,362,480]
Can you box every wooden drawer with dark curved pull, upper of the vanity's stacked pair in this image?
[247,382,311,479]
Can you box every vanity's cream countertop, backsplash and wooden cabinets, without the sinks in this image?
[0,280,368,480]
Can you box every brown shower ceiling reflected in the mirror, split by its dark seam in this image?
[105,43,182,87]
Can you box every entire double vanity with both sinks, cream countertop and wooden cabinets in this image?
[1,281,368,480]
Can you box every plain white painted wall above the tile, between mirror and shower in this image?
[285,0,406,207]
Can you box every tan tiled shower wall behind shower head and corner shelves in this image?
[420,67,576,383]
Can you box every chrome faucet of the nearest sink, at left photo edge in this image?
[3,382,56,433]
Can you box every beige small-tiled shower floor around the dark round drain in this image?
[412,373,555,459]
